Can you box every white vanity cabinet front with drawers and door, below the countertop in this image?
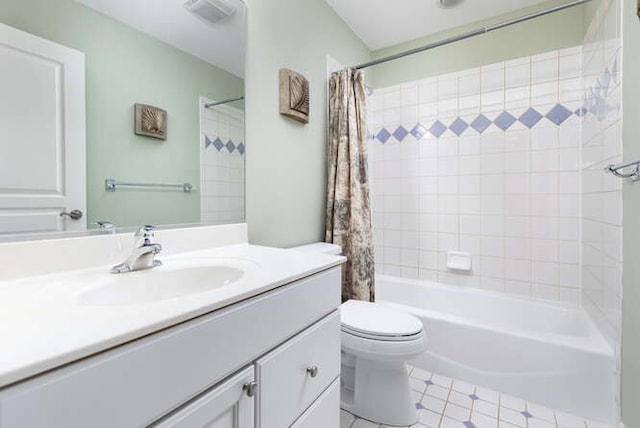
[0,267,341,428]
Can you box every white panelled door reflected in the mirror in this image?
[0,24,86,236]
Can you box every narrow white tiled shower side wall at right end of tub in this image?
[581,0,620,368]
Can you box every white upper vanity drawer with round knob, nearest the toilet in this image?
[256,311,340,428]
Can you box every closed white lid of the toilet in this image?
[340,300,422,338]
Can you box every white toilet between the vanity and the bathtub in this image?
[293,243,427,426]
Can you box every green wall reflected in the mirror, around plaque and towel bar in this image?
[0,0,243,226]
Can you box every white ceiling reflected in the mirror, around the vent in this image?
[77,0,245,77]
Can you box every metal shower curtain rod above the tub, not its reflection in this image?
[351,0,591,70]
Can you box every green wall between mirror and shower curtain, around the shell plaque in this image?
[245,0,369,246]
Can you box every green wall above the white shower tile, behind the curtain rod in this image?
[370,0,584,88]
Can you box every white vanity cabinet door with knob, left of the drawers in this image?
[151,367,255,428]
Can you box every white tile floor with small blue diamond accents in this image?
[340,367,609,428]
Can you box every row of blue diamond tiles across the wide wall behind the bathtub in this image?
[371,103,580,144]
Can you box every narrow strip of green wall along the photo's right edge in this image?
[622,0,640,428]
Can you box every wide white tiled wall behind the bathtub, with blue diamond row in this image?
[368,47,584,304]
